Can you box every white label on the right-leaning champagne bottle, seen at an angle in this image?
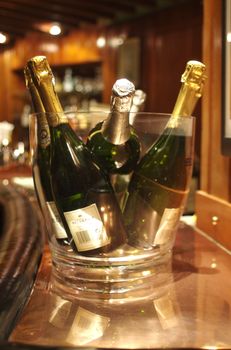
[154,208,182,245]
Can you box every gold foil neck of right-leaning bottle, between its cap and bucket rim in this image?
[172,84,201,117]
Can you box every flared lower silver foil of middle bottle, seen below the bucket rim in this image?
[101,111,131,145]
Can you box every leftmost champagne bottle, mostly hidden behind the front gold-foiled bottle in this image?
[24,67,67,243]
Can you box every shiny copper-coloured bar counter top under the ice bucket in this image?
[0,165,231,349]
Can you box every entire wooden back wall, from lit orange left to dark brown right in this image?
[0,0,202,123]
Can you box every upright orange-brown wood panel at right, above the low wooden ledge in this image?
[201,0,230,200]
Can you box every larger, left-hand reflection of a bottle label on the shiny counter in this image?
[66,306,110,345]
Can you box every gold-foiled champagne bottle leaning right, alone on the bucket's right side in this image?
[124,61,205,248]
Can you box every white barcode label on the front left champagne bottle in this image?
[64,204,111,252]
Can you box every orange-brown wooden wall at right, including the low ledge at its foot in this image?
[196,0,231,249]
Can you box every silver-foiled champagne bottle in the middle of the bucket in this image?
[87,79,140,174]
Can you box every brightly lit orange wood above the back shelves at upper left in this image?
[0,28,102,121]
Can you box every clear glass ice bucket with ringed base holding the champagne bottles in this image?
[30,111,195,300]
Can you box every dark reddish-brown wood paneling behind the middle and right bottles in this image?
[102,0,203,112]
